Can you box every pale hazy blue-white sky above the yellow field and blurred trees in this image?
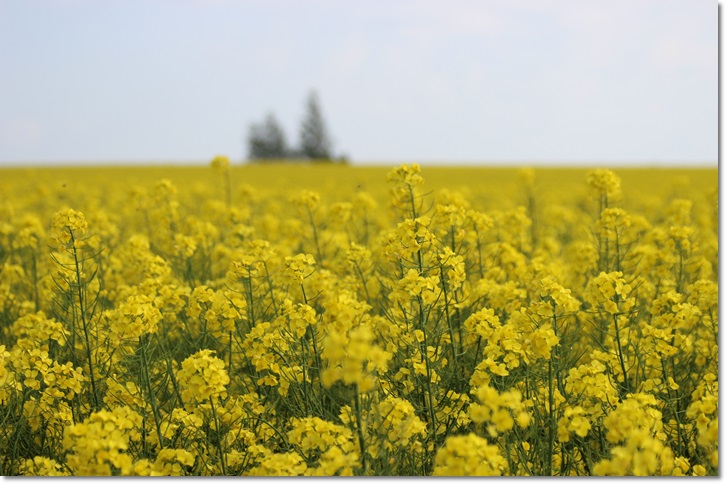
[0,0,718,166]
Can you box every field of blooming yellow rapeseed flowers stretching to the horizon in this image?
[0,163,718,476]
